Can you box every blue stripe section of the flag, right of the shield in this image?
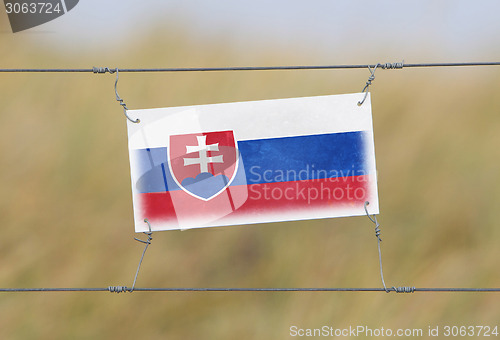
[238,131,366,184]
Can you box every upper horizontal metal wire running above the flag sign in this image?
[0,61,500,74]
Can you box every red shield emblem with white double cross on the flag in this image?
[168,131,238,201]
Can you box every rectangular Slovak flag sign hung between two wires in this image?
[127,93,379,232]
